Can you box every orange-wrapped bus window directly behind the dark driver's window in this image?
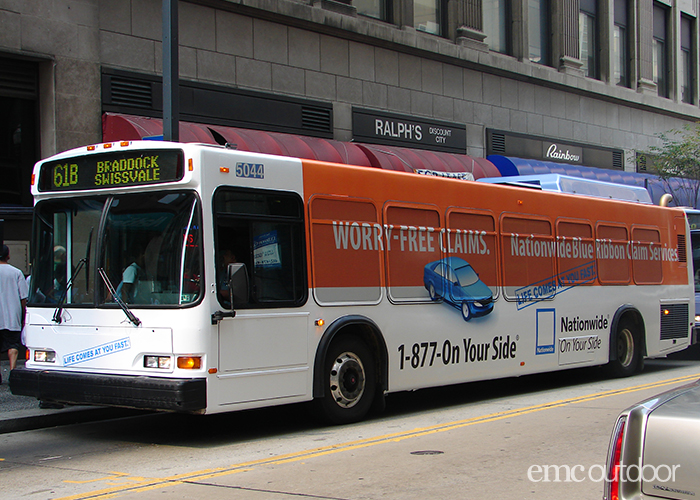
[309,197,384,305]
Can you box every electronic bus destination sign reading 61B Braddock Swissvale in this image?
[39,149,184,191]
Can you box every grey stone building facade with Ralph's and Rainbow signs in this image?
[0,0,700,270]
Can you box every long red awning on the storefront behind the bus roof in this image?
[102,113,500,179]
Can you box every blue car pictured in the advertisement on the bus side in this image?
[423,257,493,321]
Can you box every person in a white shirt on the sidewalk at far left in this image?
[0,245,29,382]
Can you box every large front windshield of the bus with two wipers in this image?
[28,191,202,307]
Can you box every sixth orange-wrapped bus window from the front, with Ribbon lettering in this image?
[596,223,630,285]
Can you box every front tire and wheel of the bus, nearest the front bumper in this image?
[318,336,377,424]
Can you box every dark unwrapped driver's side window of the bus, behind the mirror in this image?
[214,188,307,308]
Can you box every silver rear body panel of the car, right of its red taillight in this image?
[644,385,700,499]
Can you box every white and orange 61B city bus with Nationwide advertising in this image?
[10,141,695,423]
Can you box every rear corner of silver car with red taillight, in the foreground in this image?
[603,380,700,500]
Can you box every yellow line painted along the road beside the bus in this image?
[57,373,700,500]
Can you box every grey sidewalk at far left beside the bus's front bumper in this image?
[0,360,135,434]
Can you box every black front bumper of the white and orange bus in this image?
[10,367,207,413]
